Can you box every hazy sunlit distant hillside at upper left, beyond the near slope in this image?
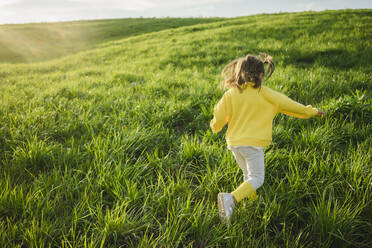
[0,18,223,63]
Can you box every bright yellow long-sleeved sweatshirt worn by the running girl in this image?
[210,84,318,147]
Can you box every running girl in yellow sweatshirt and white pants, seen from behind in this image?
[210,54,325,223]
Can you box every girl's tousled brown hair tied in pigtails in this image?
[220,53,275,90]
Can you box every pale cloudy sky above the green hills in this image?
[0,0,372,24]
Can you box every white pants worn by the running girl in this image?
[230,146,265,190]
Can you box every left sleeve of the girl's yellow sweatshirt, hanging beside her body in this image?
[210,93,229,133]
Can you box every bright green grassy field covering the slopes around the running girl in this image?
[0,10,372,248]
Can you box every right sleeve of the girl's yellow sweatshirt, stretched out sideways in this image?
[278,94,318,119]
